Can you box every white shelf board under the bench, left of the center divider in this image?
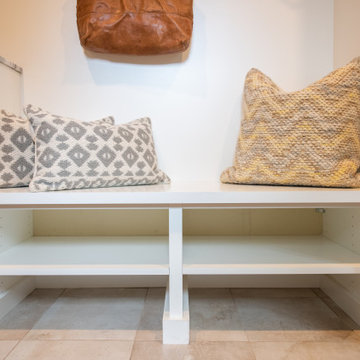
[0,236,169,275]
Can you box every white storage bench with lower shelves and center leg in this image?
[0,182,360,344]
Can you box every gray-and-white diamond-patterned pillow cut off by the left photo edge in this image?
[0,110,34,188]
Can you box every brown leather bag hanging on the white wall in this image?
[77,0,193,55]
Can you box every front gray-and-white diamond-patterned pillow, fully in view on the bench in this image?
[30,113,169,191]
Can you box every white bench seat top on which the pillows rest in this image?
[0,182,360,208]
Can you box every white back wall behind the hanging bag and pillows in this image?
[0,0,333,180]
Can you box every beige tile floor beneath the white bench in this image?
[0,288,360,360]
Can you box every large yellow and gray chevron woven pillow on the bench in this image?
[221,58,360,187]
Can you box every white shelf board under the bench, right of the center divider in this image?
[184,236,360,275]
